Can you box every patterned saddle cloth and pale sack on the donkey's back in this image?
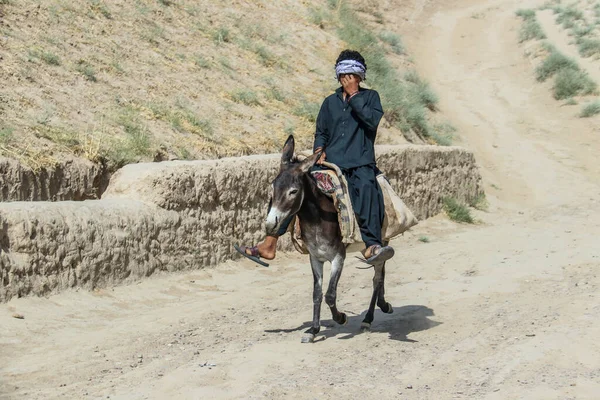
[289,152,419,254]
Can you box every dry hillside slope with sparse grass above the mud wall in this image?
[0,0,452,169]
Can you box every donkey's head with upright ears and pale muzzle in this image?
[266,135,321,235]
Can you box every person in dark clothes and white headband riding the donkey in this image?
[235,50,394,266]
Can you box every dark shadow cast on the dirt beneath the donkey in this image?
[265,305,442,342]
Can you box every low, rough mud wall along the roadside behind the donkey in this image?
[0,145,482,301]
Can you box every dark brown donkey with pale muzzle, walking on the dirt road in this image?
[266,135,394,343]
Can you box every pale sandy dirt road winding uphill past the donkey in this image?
[0,0,600,399]
